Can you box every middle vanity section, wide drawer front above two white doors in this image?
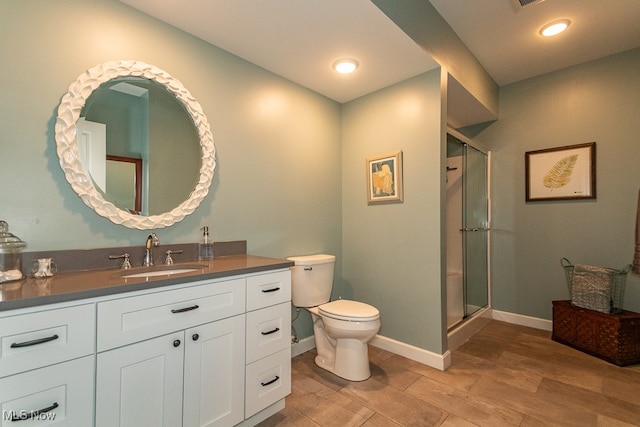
[96,278,245,427]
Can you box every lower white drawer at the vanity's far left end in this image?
[0,356,94,427]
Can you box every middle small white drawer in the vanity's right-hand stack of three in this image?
[247,302,291,363]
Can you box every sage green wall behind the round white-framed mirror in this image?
[0,0,341,270]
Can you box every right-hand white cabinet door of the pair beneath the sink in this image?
[183,315,245,427]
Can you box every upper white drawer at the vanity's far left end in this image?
[0,304,95,377]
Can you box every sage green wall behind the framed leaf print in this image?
[475,49,640,319]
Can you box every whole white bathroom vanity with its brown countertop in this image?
[0,255,291,427]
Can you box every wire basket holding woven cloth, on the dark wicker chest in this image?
[560,258,631,314]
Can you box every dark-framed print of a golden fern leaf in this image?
[524,142,596,202]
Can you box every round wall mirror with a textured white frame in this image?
[55,61,215,229]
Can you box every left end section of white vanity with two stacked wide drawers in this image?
[0,304,95,426]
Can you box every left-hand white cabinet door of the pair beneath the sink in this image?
[96,331,184,427]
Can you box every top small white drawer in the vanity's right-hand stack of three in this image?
[247,270,291,311]
